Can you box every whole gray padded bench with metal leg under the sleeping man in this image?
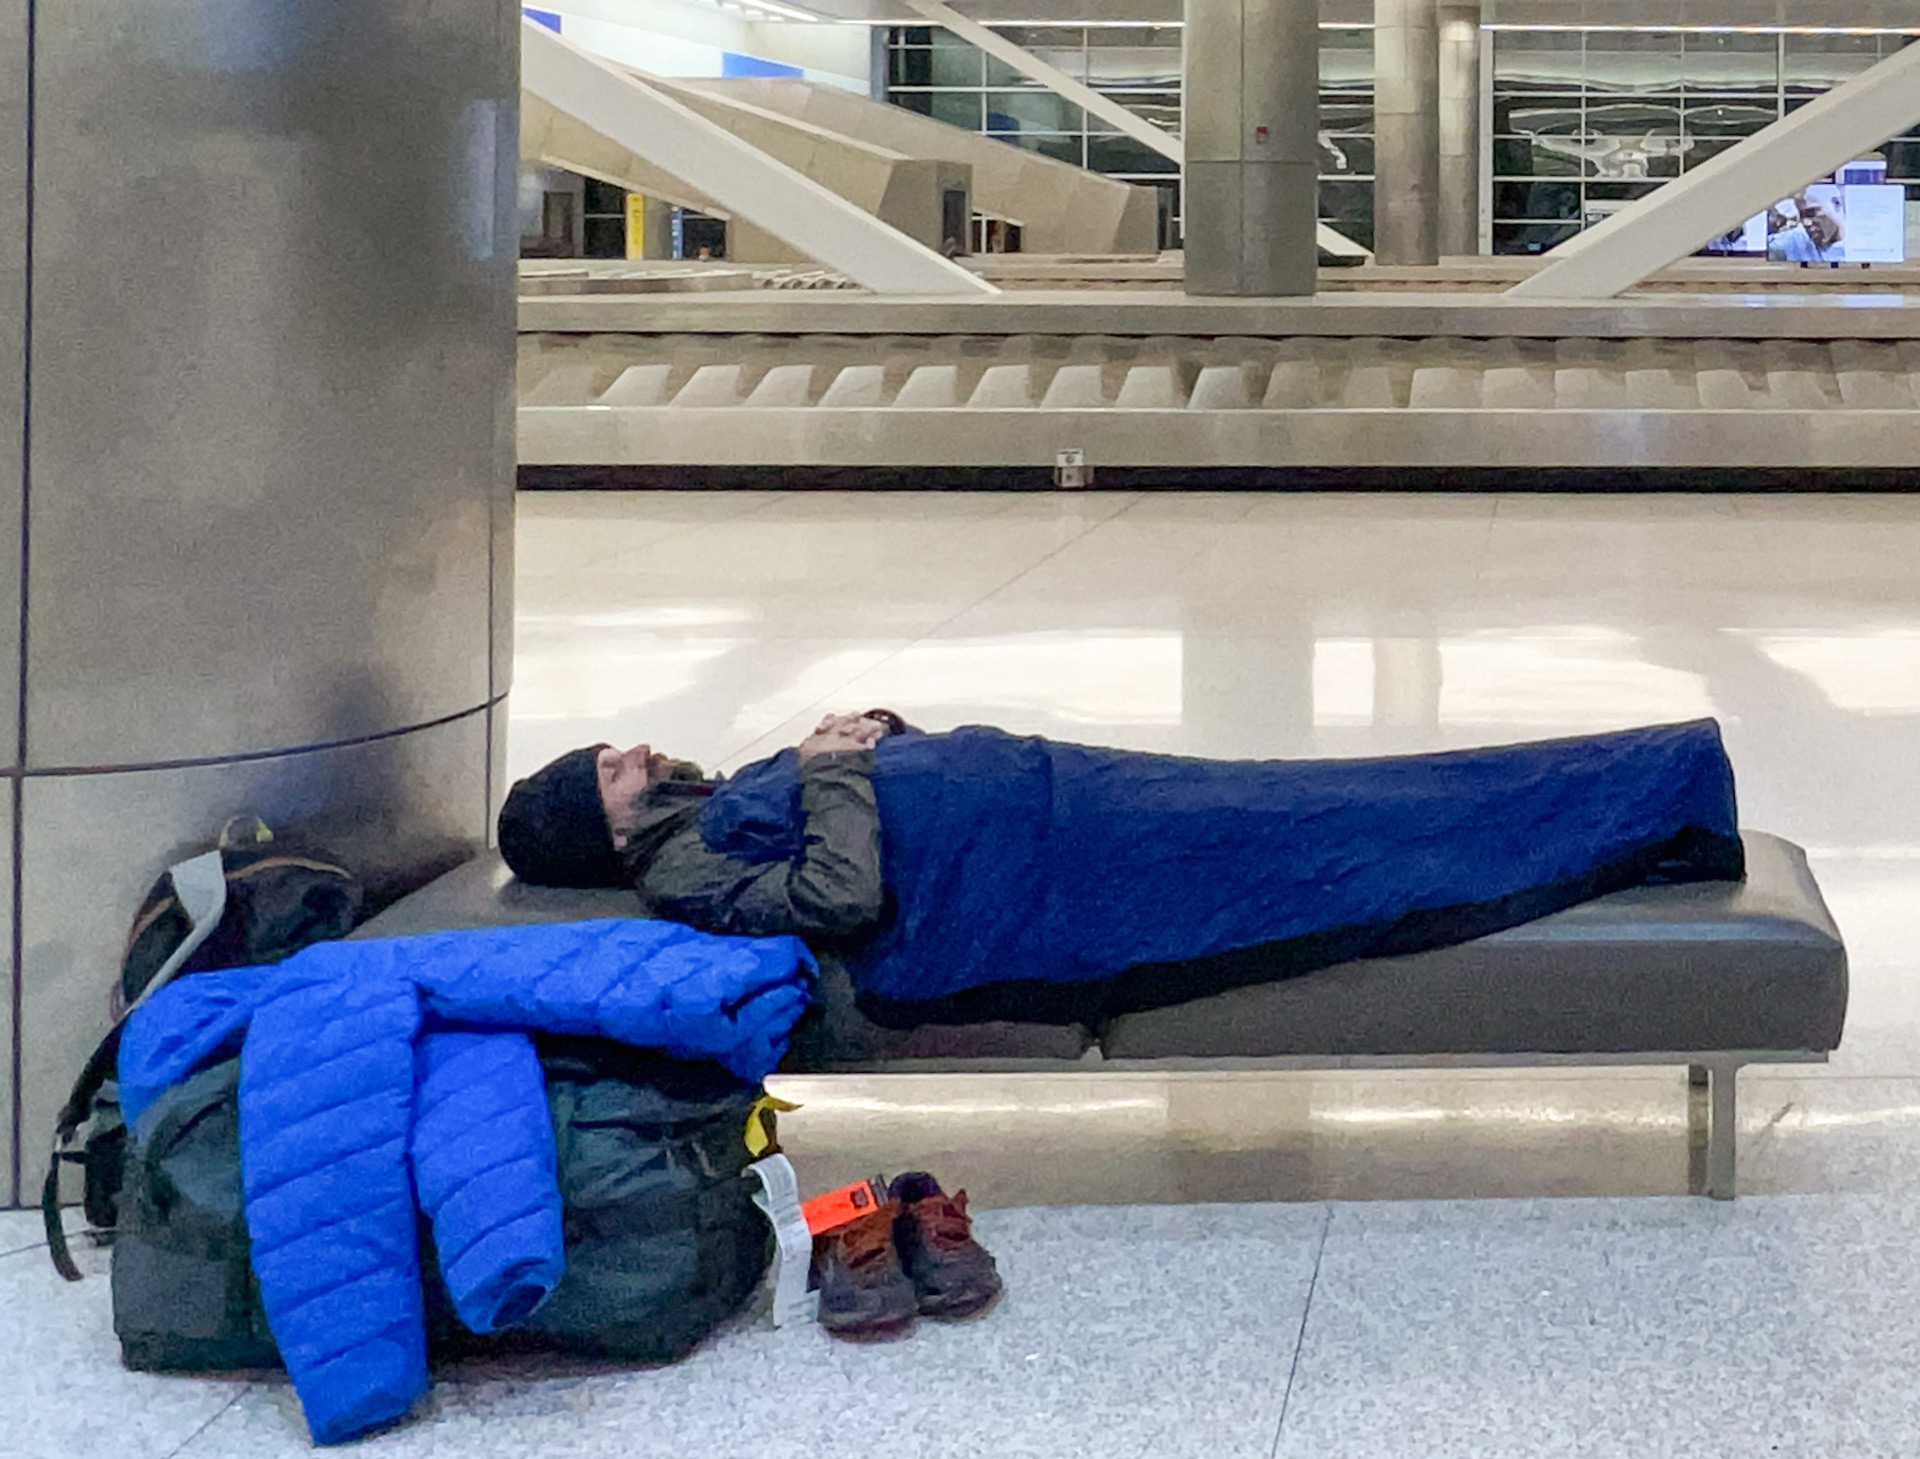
[355,831,1847,1200]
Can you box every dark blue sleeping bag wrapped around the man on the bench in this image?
[701,720,1743,1027]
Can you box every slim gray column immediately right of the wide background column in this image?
[1373,0,1440,265]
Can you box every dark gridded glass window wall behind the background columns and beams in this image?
[887,16,1920,251]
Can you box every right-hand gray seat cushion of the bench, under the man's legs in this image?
[1100,831,1847,1060]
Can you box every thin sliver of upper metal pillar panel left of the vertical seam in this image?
[0,0,27,764]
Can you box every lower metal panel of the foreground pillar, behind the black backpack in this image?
[10,710,488,1182]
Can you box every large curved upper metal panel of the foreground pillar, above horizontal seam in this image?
[22,0,518,766]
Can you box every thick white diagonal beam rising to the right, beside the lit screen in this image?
[1505,44,1920,299]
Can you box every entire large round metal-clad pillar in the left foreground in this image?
[0,0,520,1204]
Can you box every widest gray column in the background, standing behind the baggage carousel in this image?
[1185,0,1328,296]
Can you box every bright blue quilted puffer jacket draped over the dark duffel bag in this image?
[119,920,814,1444]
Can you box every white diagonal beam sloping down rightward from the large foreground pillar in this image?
[520,21,998,298]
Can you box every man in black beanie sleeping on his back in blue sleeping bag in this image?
[499,710,1743,1029]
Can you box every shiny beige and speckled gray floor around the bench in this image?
[15,493,1920,1459]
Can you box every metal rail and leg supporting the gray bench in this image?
[781,1046,1828,1200]
